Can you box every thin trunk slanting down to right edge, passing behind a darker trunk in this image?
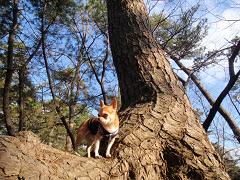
[171,56,240,143]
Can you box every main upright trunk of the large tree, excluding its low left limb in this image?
[107,0,229,179]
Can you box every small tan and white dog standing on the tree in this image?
[75,98,119,158]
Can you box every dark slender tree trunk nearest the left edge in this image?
[3,0,18,136]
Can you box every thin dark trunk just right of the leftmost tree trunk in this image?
[18,65,26,131]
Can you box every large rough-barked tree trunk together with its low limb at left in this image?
[0,0,229,180]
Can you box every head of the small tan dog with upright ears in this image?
[98,98,117,124]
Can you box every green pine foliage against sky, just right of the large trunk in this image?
[150,5,207,58]
